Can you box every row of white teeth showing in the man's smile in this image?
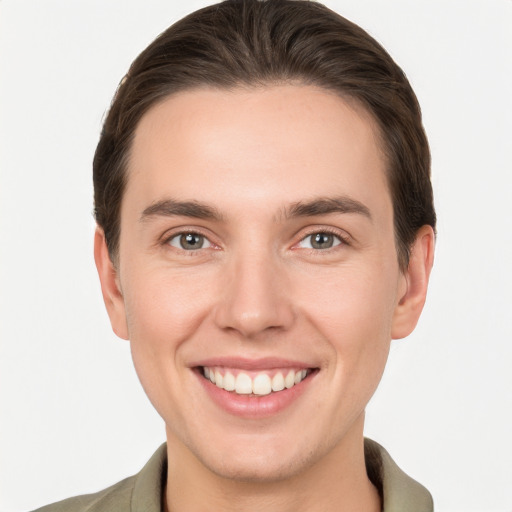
[199,366,315,396]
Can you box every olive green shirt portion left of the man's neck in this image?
[34,444,167,512]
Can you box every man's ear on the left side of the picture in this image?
[94,226,128,340]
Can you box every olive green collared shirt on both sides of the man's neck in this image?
[34,439,434,512]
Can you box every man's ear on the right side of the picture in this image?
[391,226,435,339]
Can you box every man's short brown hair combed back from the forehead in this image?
[93,0,436,270]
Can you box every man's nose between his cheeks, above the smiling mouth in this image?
[214,249,294,339]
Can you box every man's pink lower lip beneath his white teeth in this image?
[196,370,317,418]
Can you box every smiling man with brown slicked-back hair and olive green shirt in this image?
[37,0,435,512]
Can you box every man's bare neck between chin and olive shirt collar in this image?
[165,418,381,512]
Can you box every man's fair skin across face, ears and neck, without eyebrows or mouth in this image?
[95,85,434,512]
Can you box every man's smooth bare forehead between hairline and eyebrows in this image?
[123,85,389,218]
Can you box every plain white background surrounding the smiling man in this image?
[0,0,512,512]
